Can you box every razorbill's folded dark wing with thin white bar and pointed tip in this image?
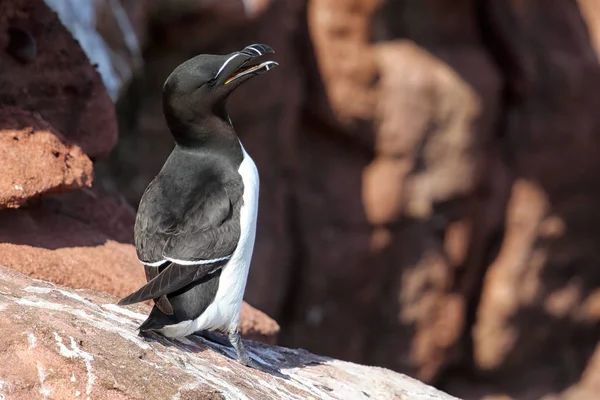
[119,181,241,305]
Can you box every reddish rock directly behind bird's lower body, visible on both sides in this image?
[0,188,279,344]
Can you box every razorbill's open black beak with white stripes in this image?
[216,44,279,85]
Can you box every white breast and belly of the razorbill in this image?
[162,142,259,337]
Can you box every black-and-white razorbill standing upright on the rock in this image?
[118,44,278,365]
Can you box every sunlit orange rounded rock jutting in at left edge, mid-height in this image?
[0,107,93,209]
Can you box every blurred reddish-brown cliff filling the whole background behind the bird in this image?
[0,0,600,400]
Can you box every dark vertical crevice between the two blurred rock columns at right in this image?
[435,0,525,388]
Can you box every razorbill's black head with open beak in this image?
[162,44,278,145]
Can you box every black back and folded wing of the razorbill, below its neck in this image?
[119,142,243,317]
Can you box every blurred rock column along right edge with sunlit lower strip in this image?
[473,1,600,396]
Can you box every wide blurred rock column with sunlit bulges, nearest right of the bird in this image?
[281,0,501,381]
